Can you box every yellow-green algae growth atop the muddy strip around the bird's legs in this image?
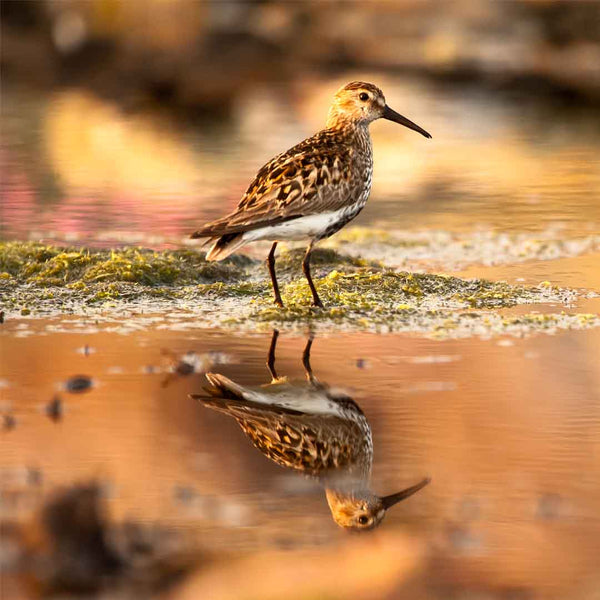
[0,242,547,314]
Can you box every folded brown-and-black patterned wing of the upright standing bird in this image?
[192,130,361,237]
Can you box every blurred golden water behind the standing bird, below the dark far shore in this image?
[1,73,600,243]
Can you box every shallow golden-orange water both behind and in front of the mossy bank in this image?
[0,74,600,600]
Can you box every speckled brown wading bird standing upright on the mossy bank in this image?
[191,81,431,308]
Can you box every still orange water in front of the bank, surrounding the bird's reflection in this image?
[0,321,600,598]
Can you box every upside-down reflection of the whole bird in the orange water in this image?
[192,331,429,530]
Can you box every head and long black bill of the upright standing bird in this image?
[327,81,431,138]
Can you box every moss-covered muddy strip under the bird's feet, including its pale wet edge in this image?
[0,242,600,337]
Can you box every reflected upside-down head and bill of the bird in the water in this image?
[326,478,430,531]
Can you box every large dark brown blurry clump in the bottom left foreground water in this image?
[9,482,201,598]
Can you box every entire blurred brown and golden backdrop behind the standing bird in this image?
[0,0,600,243]
